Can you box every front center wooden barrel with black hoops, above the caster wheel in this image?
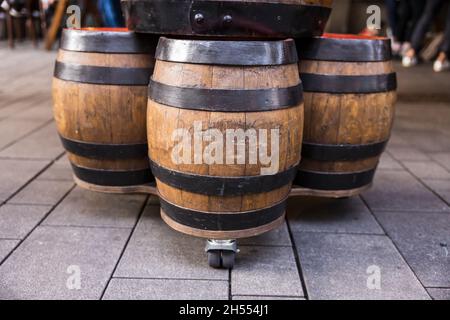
[147,38,303,239]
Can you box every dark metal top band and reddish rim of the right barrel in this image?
[297,33,392,62]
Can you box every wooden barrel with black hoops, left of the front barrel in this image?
[53,29,157,192]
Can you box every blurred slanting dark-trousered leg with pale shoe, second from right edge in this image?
[402,0,445,67]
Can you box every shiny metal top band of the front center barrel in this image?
[156,37,298,66]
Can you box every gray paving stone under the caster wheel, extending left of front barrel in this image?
[114,206,228,280]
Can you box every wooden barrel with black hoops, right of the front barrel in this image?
[295,34,397,197]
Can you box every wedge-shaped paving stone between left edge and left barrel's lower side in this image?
[0,123,64,160]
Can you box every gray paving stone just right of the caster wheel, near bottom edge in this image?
[231,246,304,297]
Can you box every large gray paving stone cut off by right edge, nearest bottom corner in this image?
[376,212,450,288]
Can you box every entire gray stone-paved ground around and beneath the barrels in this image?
[0,47,450,300]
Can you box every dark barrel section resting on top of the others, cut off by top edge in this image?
[122,0,333,39]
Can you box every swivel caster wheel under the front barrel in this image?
[205,240,239,269]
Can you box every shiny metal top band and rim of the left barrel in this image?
[60,28,158,53]
